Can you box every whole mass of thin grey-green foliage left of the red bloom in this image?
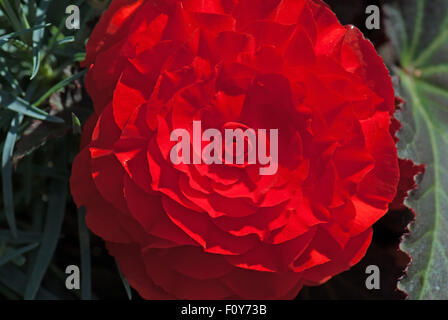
[0,0,100,299]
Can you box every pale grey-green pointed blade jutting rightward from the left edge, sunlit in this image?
[0,90,64,123]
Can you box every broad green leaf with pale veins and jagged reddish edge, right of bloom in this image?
[385,0,448,299]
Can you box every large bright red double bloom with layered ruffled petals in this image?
[71,0,399,299]
